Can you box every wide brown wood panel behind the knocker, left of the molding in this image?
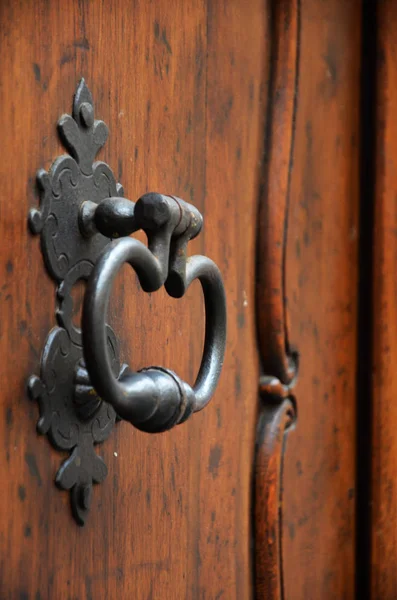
[0,0,268,600]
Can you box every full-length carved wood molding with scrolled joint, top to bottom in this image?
[253,0,300,600]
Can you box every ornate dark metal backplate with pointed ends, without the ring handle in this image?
[28,80,123,525]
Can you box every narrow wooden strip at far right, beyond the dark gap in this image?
[370,0,397,600]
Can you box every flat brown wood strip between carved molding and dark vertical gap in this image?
[283,0,361,600]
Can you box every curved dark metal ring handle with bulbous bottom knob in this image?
[82,238,226,432]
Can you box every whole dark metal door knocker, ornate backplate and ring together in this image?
[28,80,226,525]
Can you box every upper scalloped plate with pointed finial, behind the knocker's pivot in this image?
[29,79,123,282]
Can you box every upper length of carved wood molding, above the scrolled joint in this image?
[256,0,300,385]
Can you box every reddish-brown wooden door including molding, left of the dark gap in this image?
[0,0,361,600]
